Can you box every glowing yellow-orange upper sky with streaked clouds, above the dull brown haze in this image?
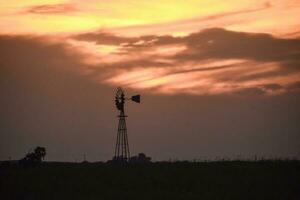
[0,0,300,95]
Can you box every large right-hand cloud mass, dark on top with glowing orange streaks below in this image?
[73,28,300,95]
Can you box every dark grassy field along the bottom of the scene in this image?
[0,161,300,200]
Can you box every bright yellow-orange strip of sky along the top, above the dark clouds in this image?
[0,0,300,35]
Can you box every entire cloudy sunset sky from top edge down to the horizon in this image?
[0,0,300,161]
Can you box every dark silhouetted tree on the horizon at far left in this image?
[20,146,46,166]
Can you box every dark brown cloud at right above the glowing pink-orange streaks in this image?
[74,28,300,86]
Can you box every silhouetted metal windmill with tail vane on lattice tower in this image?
[113,87,141,162]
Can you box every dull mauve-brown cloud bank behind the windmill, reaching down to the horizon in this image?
[0,36,300,161]
